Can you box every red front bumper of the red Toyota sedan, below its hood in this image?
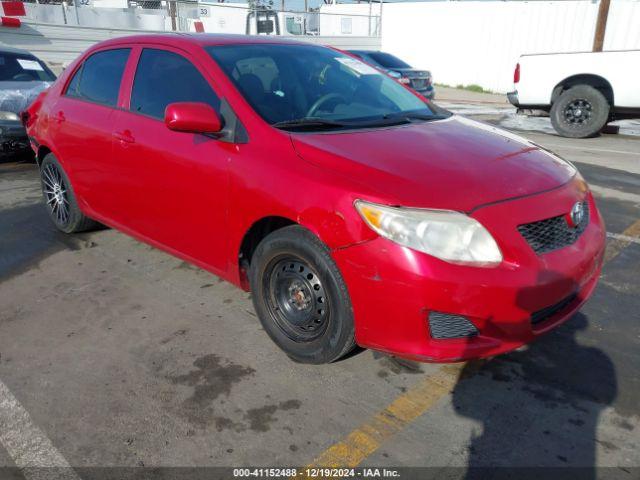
[334,181,605,362]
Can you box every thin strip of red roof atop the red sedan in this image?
[96,32,320,47]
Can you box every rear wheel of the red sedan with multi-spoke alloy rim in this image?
[40,153,100,233]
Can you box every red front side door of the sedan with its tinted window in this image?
[111,45,236,270]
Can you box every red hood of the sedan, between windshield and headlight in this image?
[291,115,576,212]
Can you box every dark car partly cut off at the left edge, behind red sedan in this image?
[0,46,56,157]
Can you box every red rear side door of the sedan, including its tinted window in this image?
[48,48,131,215]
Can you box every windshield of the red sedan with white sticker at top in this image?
[207,44,443,128]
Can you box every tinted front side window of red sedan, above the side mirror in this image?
[131,48,220,119]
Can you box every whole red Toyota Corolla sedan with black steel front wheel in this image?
[23,34,605,363]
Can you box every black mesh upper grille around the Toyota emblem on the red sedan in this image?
[518,202,589,254]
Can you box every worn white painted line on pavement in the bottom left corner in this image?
[0,381,80,480]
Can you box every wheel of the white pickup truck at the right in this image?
[550,85,611,138]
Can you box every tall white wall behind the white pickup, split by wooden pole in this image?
[323,0,640,93]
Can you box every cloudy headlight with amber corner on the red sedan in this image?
[355,200,502,266]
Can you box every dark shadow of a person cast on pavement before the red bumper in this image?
[452,264,618,480]
